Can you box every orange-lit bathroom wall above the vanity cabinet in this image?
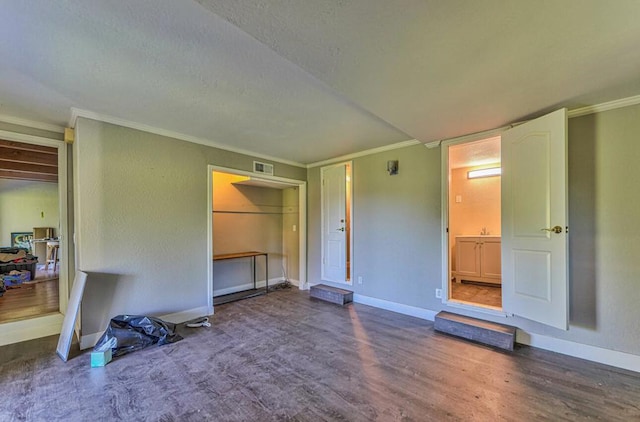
[449,164,500,270]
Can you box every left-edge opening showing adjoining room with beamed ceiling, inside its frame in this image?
[0,140,61,323]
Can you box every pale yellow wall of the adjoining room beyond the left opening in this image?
[0,179,60,246]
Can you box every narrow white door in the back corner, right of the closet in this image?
[322,164,347,283]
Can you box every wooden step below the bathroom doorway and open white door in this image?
[434,311,516,351]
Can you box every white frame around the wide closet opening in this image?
[207,164,309,315]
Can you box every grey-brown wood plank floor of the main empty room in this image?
[0,290,640,421]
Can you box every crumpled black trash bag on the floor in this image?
[93,315,182,357]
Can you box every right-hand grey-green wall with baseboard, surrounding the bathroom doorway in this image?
[308,102,640,355]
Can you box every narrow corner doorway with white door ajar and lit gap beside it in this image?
[320,161,353,285]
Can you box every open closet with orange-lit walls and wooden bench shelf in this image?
[208,166,308,311]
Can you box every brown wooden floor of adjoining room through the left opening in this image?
[0,269,59,323]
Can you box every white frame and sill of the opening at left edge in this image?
[0,130,72,346]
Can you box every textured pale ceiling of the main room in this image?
[0,0,640,164]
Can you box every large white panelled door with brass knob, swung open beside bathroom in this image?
[502,109,569,330]
